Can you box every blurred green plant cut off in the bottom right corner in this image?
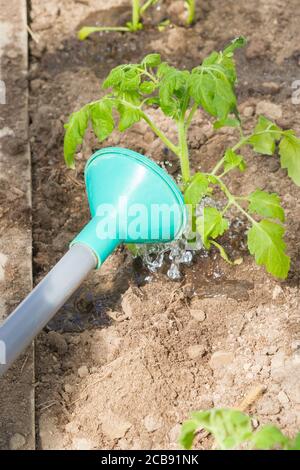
[179,409,300,450]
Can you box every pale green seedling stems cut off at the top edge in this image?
[78,0,196,41]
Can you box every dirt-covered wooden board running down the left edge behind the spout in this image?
[0,0,35,449]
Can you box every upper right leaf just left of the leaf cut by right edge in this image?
[249,116,281,155]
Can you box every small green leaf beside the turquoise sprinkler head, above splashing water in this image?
[197,207,229,248]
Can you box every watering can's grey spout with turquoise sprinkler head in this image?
[0,148,186,376]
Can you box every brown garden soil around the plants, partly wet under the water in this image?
[29,0,300,449]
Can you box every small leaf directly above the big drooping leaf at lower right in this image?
[247,189,284,222]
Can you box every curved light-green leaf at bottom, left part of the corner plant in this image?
[180,409,252,450]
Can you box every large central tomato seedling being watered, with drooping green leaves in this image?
[64,37,300,279]
